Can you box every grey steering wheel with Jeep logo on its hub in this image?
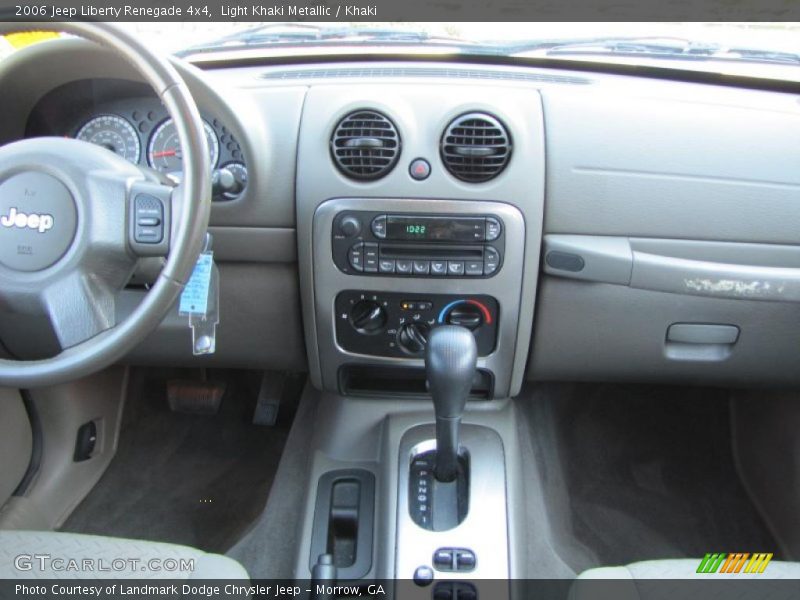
[0,22,211,388]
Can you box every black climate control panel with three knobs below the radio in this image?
[335,290,498,358]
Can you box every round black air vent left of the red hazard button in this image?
[331,110,400,180]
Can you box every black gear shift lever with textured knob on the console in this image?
[425,325,478,482]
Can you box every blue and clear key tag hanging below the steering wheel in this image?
[178,233,219,356]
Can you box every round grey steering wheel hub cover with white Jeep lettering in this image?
[0,171,78,271]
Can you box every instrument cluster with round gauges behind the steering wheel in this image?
[69,98,247,200]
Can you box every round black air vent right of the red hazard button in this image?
[441,113,511,183]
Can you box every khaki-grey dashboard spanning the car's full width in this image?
[0,40,800,397]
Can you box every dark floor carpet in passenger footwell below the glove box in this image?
[525,385,780,570]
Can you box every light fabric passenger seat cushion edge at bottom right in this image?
[569,558,800,600]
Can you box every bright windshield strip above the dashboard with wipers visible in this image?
[9,20,800,81]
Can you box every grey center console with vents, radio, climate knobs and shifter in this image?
[296,81,545,600]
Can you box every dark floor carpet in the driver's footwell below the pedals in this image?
[61,369,302,552]
